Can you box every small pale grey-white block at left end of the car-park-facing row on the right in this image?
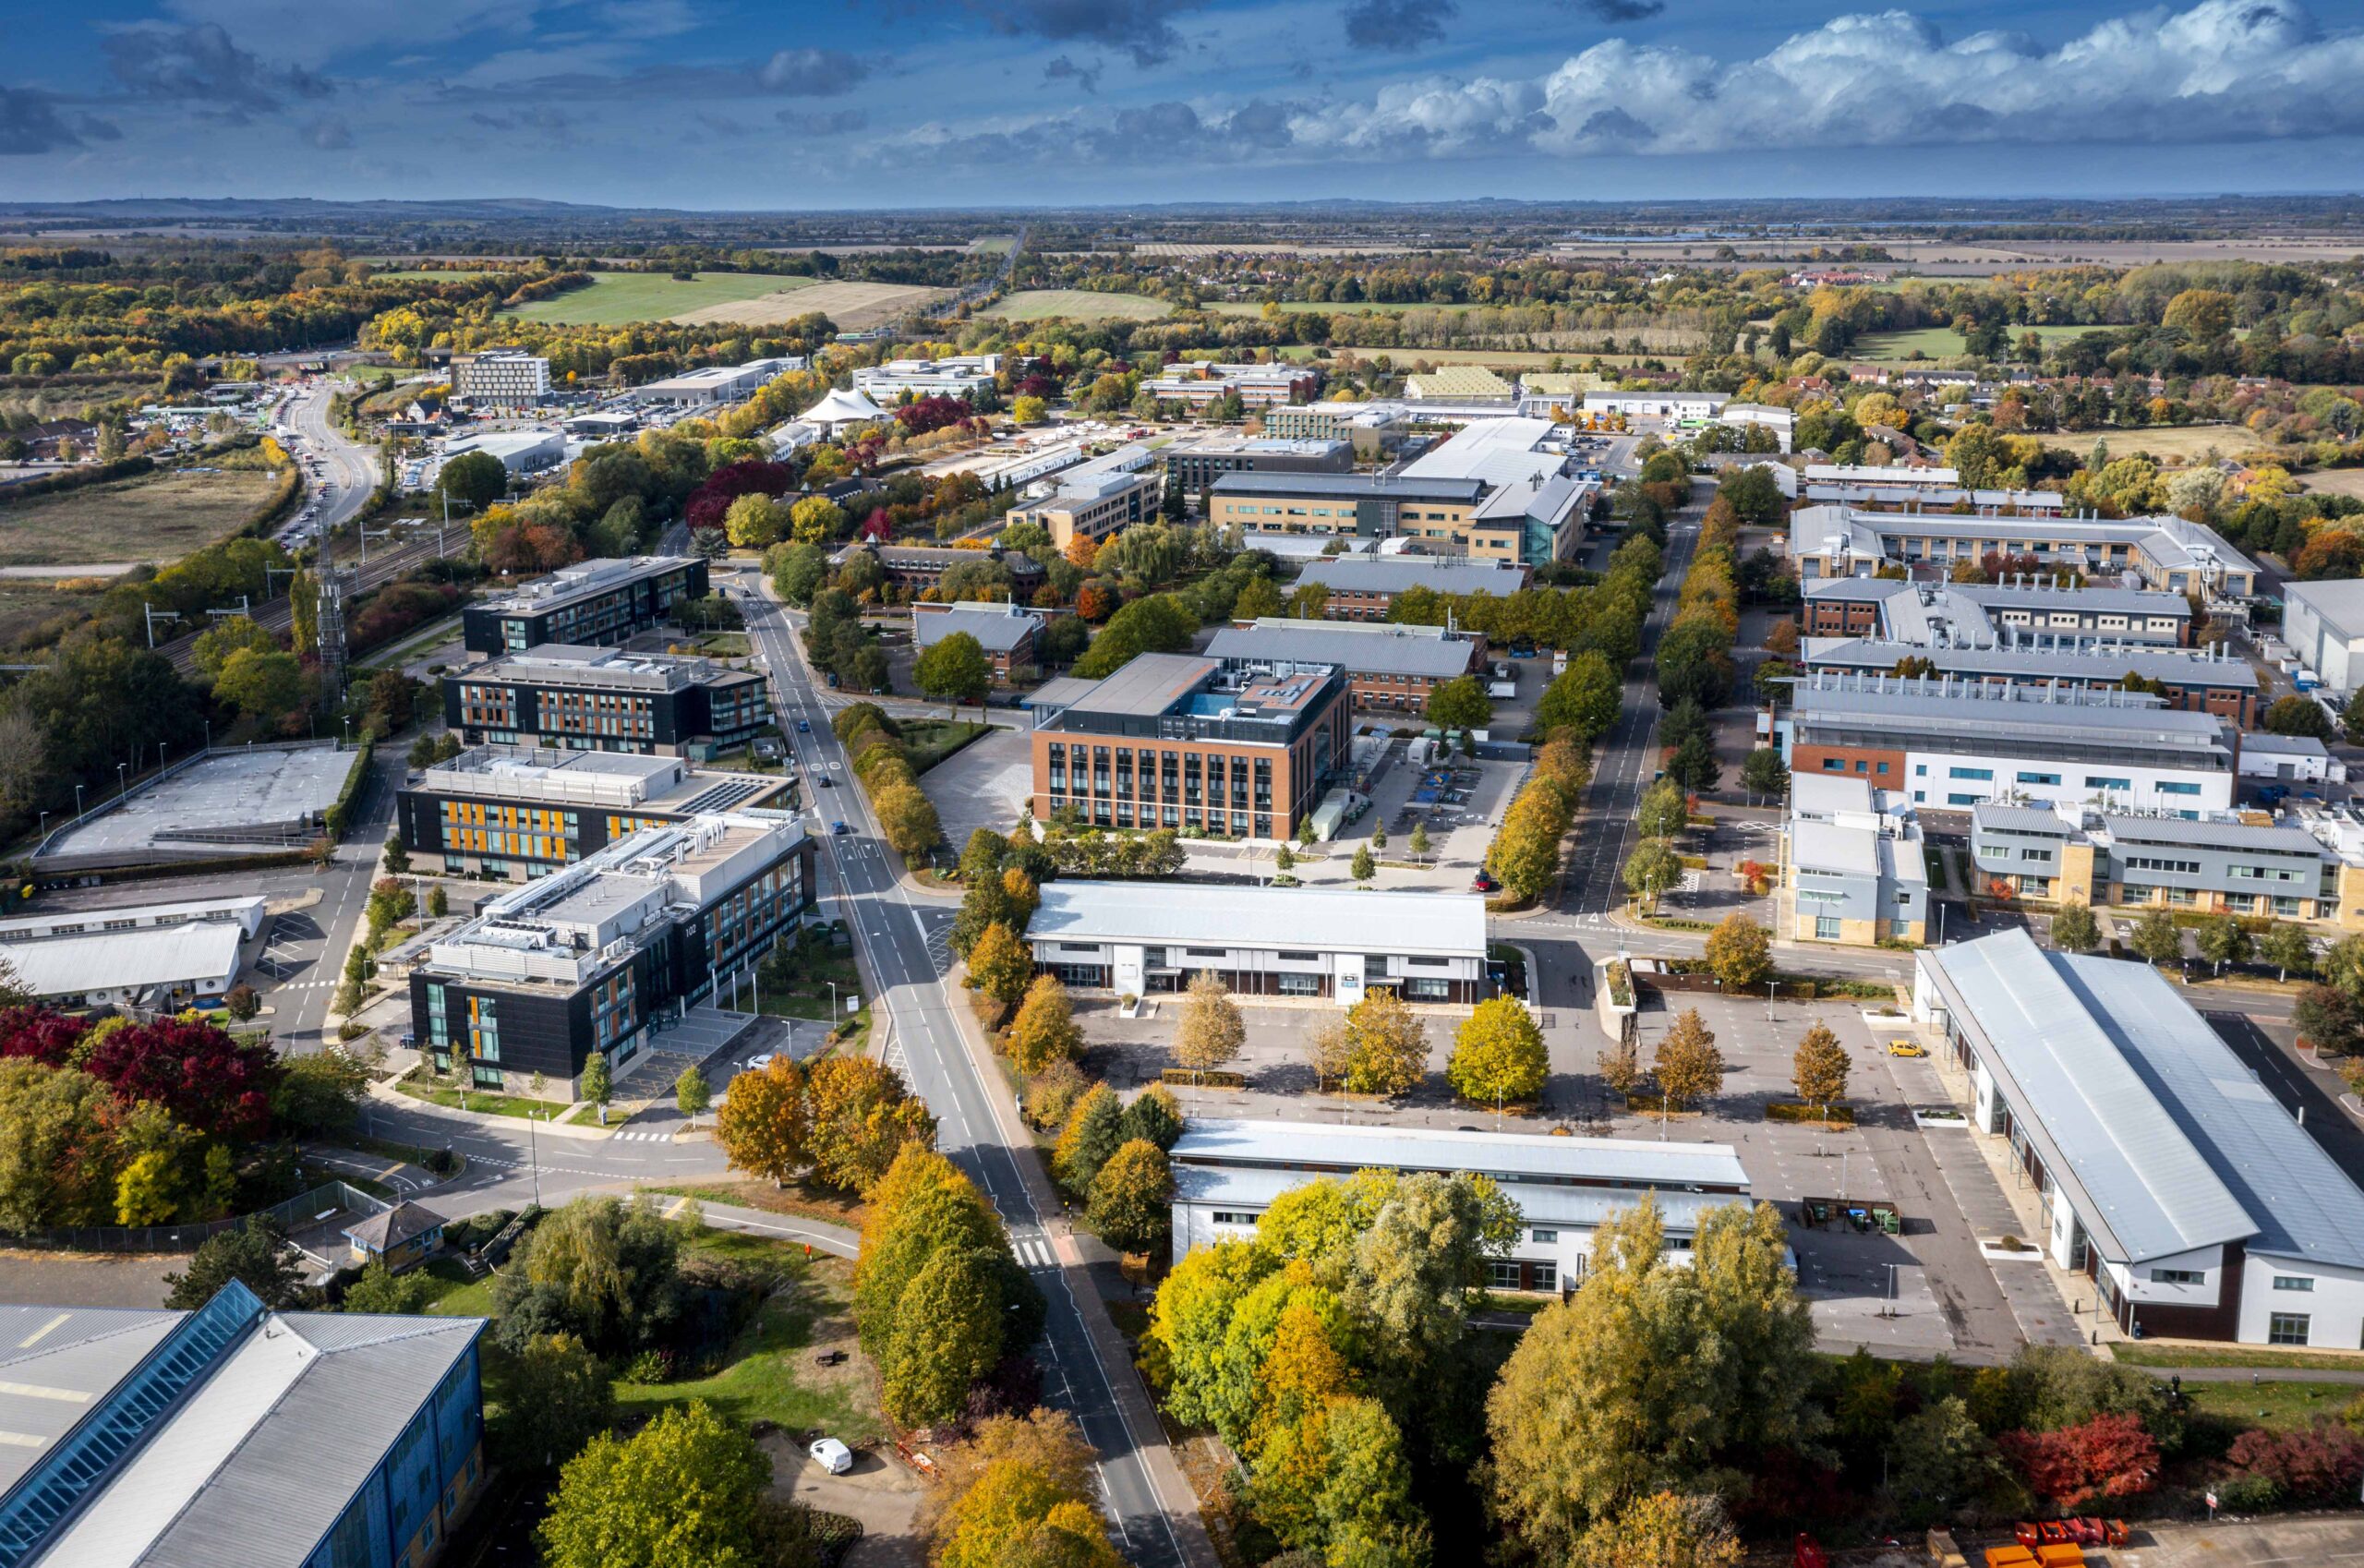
[1776,773,1929,946]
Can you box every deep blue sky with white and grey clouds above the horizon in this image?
[0,0,2364,208]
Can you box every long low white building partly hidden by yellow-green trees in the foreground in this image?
[1173,1116,1749,1294]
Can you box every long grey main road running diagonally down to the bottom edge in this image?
[740,560,1206,1568]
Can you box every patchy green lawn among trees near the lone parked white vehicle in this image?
[615,1232,886,1442]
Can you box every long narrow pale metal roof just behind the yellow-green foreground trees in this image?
[1172,1116,1749,1192]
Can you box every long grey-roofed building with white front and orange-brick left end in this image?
[1773,674,2238,811]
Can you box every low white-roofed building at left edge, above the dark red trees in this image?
[0,897,262,1010]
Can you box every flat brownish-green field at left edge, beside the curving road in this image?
[0,468,271,565]
